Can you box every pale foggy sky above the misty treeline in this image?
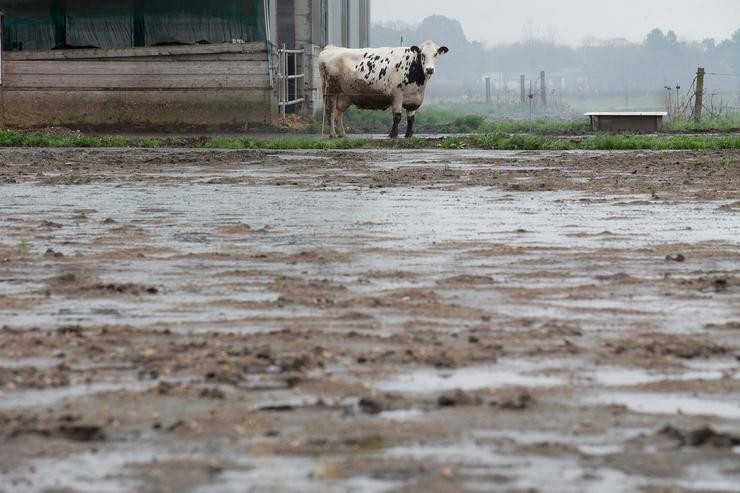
[371,0,740,46]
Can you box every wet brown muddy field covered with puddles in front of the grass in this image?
[0,149,740,493]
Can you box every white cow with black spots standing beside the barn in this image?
[319,41,449,139]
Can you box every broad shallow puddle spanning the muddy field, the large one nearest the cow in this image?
[0,185,740,252]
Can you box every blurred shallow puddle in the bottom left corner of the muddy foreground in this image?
[0,443,399,493]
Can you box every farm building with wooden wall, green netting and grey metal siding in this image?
[0,0,370,129]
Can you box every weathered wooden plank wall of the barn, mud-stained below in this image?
[0,43,277,129]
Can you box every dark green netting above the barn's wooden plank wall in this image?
[0,0,265,51]
